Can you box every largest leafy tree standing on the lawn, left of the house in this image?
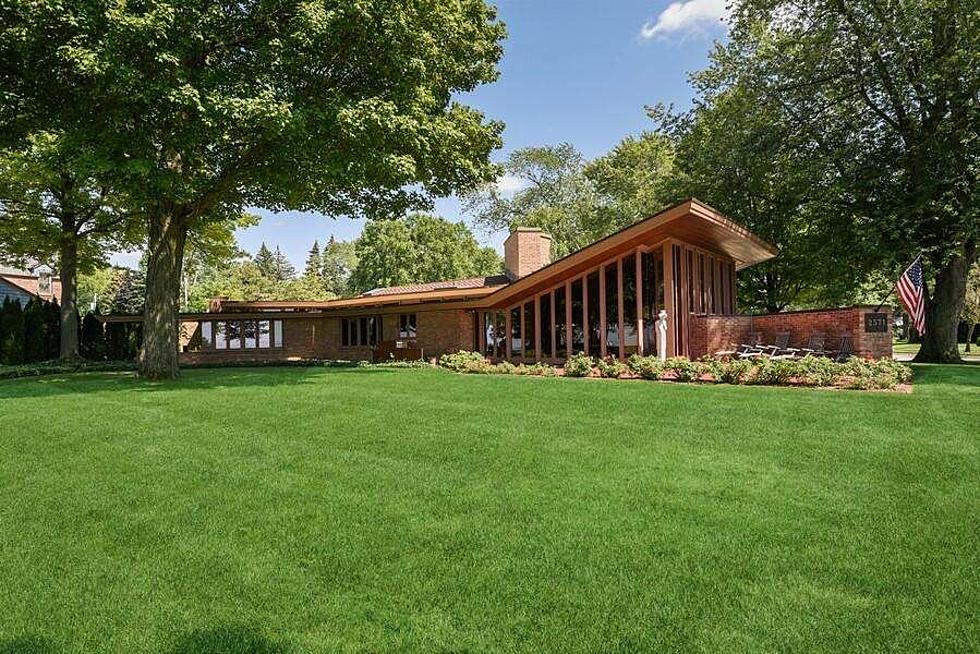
[0,0,504,378]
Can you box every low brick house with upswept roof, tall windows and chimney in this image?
[106,199,891,363]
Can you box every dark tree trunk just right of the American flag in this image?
[914,243,976,363]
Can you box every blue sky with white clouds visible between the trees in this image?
[117,0,726,267]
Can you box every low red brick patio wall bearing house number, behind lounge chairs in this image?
[690,306,892,359]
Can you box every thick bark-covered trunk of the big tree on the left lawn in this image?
[139,208,187,379]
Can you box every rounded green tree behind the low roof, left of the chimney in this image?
[350,214,502,293]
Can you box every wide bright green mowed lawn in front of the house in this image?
[0,366,980,654]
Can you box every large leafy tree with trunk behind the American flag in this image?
[731,0,980,361]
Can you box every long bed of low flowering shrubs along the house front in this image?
[439,351,912,390]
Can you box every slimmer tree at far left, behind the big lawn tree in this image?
[0,133,131,360]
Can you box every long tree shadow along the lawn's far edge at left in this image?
[0,366,408,402]
